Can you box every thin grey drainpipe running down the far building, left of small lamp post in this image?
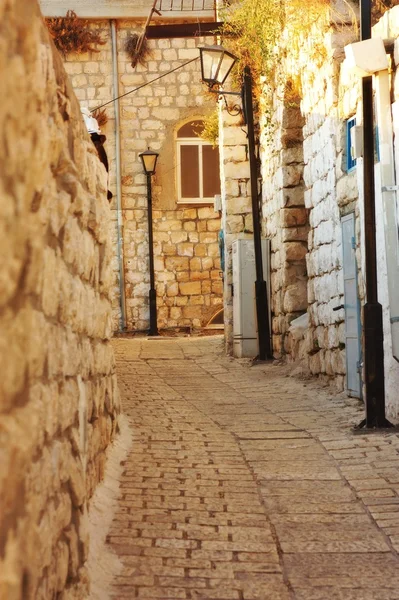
[110,19,126,331]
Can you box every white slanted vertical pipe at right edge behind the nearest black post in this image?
[375,70,399,360]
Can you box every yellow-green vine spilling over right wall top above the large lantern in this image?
[223,0,356,134]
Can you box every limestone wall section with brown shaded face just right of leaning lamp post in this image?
[262,87,309,358]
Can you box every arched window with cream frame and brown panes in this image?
[177,120,220,204]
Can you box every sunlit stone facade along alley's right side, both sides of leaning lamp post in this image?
[221,2,399,416]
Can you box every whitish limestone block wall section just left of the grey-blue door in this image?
[302,55,346,388]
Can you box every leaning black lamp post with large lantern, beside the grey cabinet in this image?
[199,45,273,360]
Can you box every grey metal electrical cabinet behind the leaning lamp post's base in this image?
[233,239,271,358]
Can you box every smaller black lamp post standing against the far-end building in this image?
[139,149,159,335]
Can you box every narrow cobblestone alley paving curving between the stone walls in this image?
[107,337,399,600]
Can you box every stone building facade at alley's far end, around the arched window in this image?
[42,0,227,331]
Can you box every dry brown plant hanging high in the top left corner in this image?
[45,10,105,56]
